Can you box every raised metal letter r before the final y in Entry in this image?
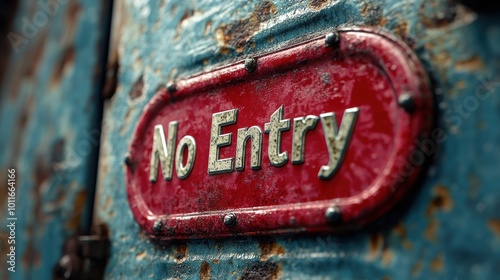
[292,116,319,164]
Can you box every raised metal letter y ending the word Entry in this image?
[318,107,359,179]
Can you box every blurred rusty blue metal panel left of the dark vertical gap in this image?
[0,0,109,279]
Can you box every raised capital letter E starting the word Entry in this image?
[208,109,238,175]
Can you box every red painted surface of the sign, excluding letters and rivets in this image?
[126,29,432,240]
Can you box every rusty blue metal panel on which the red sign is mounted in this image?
[96,0,500,279]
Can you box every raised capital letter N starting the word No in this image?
[149,121,177,183]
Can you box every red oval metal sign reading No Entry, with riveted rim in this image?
[126,29,432,240]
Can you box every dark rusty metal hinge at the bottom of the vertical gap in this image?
[53,225,110,280]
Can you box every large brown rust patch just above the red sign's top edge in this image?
[215,1,277,53]
